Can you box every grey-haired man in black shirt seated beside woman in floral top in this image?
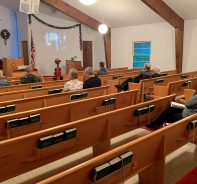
[83,67,101,89]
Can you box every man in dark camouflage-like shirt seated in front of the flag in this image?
[20,65,42,84]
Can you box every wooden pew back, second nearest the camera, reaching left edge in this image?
[0,95,175,181]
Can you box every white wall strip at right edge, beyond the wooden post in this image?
[183,19,197,72]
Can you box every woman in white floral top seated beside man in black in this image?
[63,68,83,91]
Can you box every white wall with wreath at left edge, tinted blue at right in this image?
[0,6,18,58]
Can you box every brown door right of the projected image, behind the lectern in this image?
[83,41,92,67]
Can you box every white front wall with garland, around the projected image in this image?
[28,4,105,75]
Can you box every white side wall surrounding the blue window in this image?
[111,23,176,71]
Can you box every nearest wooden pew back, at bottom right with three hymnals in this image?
[37,115,197,184]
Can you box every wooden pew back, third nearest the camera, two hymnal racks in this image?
[0,90,137,140]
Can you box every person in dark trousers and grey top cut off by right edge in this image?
[146,92,197,130]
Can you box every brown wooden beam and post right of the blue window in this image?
[141,0,184,73]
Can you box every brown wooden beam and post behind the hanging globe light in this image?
[41,0,111,68]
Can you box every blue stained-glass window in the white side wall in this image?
[133,42,151,68]
